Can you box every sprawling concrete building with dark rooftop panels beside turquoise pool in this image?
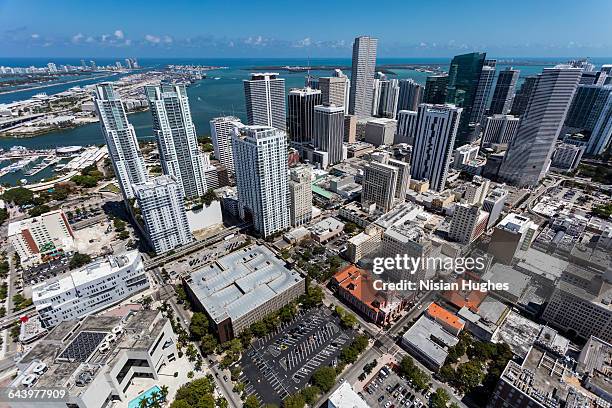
[9,310,178,408]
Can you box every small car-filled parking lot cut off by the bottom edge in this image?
[362,366,429,408]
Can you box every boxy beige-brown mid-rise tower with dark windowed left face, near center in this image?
[361,162,398,213]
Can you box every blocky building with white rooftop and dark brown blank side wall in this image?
[487,213,538,265]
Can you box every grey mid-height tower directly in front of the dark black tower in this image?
[313,105,344,166]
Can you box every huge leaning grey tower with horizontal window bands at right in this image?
[498,65,582,187]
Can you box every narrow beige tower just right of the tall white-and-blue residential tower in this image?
[289,165,312,227]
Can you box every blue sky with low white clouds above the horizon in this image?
[0,0,612,58]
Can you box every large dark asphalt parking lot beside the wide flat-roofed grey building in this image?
[240,308,355,405]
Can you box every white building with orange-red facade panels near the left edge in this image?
[8,210,74,266]
